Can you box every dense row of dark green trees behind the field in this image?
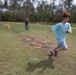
[0,0,76,22]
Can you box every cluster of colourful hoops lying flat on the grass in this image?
[18,36,52,48]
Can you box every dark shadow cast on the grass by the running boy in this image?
[26,56,54,73]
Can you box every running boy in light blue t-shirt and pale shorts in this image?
[47,11,72,56]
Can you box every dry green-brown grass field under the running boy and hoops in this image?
[0,22,76,75]
